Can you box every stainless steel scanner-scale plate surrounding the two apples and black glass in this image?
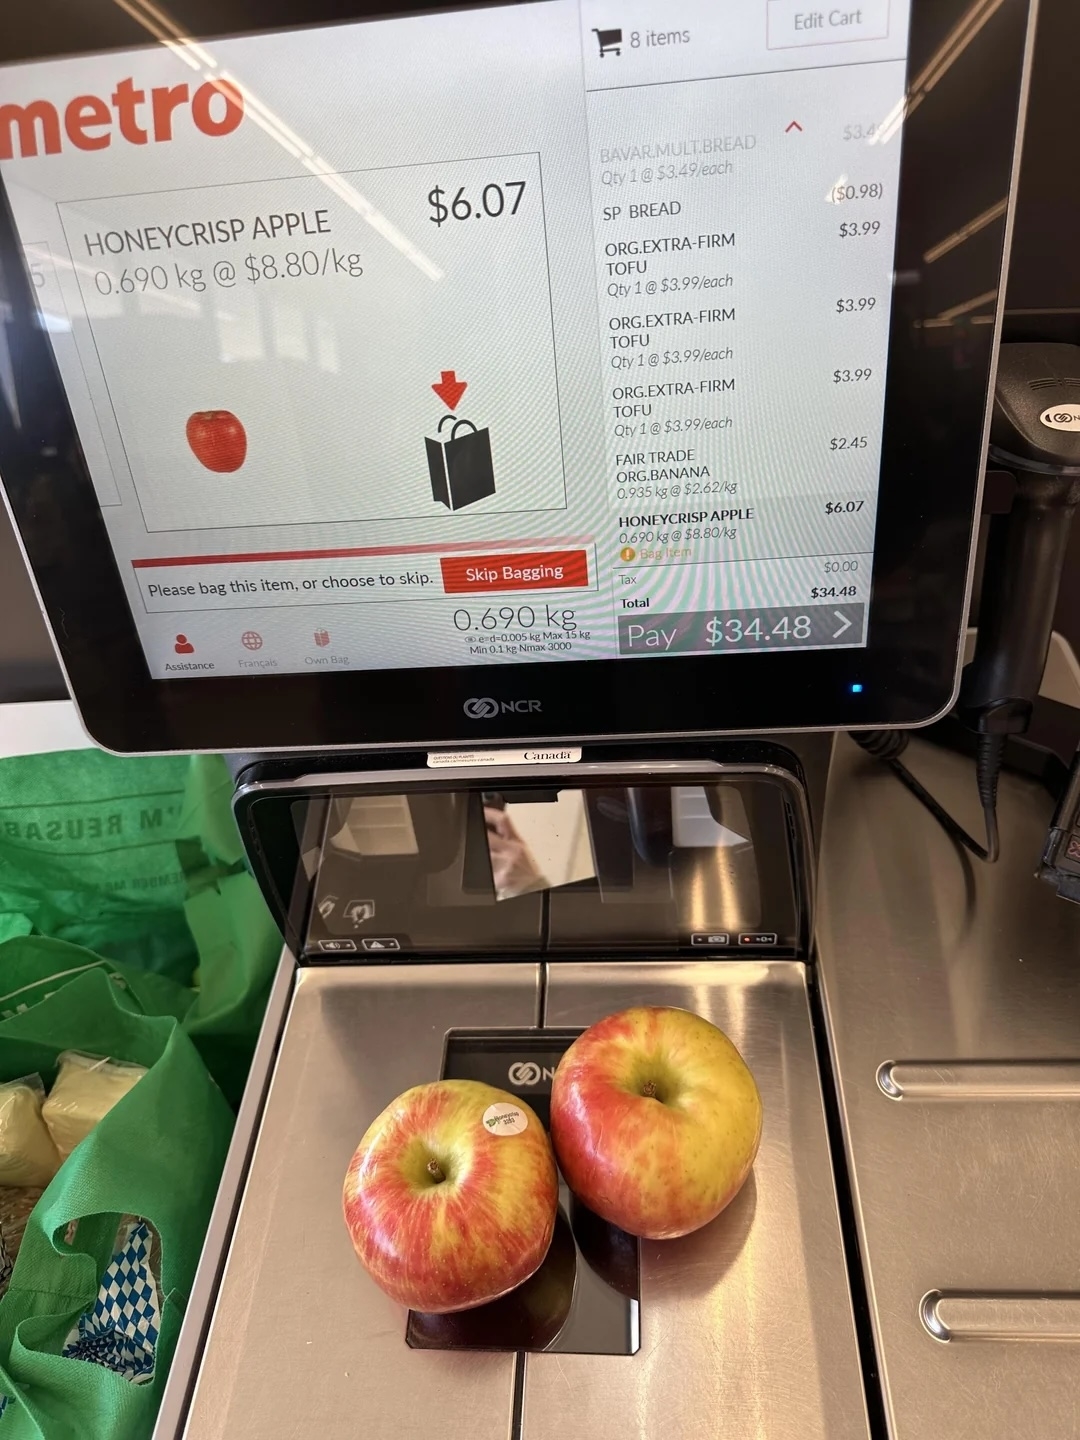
[183,960,867,1440]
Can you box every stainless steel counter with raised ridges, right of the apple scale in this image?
[818,737,1080,1440]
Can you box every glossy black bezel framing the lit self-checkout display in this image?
[0,0,1030,753]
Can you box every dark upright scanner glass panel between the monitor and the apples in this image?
[280,776,801,962]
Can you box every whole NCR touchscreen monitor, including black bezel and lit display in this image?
[0,0,1028,750]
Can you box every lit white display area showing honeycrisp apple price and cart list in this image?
[0,0,907,678]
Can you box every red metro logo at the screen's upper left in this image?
[0,78,243,160]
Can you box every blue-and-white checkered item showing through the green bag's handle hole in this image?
[62,1221,161,1385]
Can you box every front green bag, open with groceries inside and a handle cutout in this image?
[0,939,233,1440]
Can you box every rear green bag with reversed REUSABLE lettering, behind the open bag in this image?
[0,750,281,1104]
